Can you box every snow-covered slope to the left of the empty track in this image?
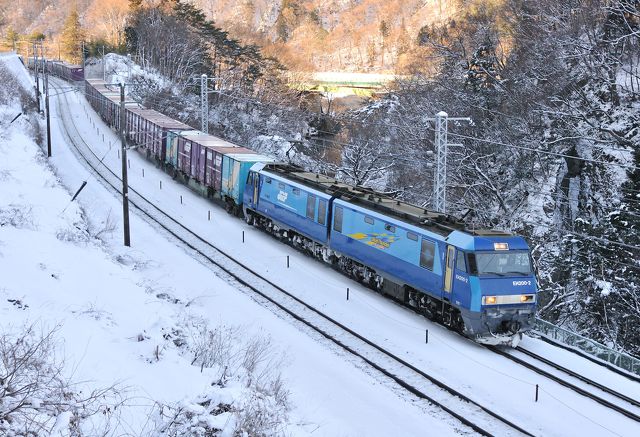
[0,54,457,436]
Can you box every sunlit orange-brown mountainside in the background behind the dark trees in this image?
[0,0,456,71]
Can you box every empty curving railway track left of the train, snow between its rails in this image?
[54,76,533,436]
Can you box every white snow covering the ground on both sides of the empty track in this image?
[0,52,640,436]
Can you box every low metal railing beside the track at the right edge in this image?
[536,318,640,375]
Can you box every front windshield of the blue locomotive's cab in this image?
[469,250,532,276]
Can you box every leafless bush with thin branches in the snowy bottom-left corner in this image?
[0,325,124,436]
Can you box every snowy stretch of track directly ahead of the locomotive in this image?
[489,346,640,422]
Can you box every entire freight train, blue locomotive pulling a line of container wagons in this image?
[42,63,537,346]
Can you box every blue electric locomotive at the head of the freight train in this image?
[243,163,537,345]
